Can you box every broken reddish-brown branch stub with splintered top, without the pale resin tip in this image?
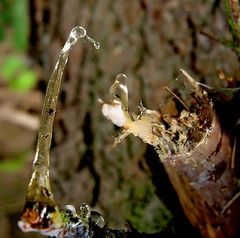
[153,71,240,238]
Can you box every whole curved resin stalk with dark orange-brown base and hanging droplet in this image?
[18,26,99,236]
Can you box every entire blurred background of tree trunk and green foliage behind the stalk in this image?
[0,0,240,238]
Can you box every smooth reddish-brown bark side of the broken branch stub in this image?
[156,79,240,237]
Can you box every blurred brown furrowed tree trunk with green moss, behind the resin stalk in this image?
[0,0,239,237]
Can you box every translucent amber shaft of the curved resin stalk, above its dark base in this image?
[27,27,86,203]
